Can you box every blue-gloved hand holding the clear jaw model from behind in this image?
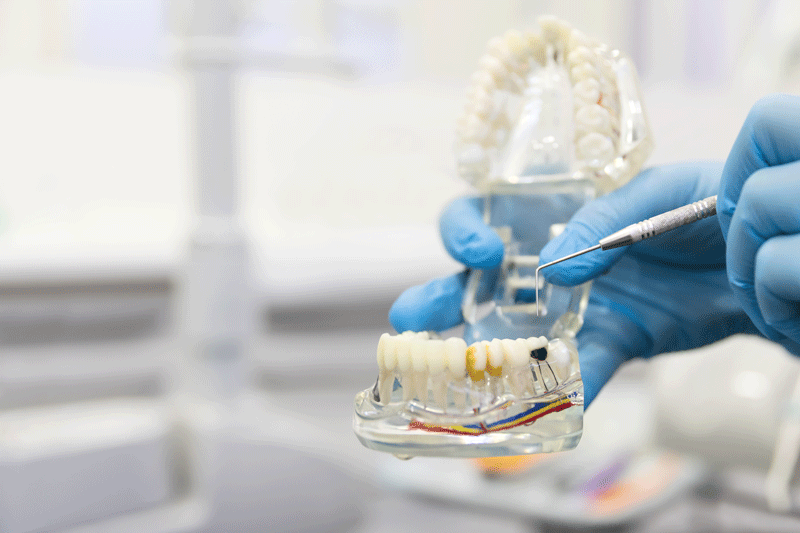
[389,163,756,405]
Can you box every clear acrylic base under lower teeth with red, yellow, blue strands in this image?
[353,363,583,458]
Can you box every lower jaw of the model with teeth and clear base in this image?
[353,332,583,458]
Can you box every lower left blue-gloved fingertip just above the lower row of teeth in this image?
[389,269,498,332]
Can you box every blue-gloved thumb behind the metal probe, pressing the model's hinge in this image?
[539,164,717,286]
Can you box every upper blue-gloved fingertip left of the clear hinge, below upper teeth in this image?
[439,198,503,269]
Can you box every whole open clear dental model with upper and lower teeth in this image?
[354,17,652,457]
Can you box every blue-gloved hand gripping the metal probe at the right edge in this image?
[717,95,800,355]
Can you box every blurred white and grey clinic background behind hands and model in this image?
[0,0,800,533]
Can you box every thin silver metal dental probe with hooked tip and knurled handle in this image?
[534,195,717,316]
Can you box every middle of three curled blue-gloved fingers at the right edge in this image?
[727,161,800,340]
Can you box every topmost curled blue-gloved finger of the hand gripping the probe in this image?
[717,94,800,239]
